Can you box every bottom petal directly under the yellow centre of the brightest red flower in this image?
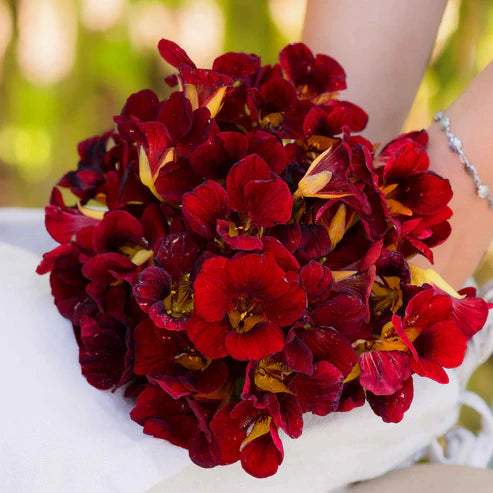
[226,322,284,361]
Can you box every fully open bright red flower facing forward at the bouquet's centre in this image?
[187,254,306,360]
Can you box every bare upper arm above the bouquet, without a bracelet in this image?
[303,0,447,143]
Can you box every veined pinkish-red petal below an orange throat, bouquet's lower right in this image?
[358,351,411,395]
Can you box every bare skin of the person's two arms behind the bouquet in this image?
[303,0,493,289]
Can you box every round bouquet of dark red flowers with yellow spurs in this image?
[38,40,488,478]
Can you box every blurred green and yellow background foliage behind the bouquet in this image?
[0,0,493,427]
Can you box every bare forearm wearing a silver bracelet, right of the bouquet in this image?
[415,62,493,288]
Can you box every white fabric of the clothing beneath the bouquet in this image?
[0,209,488,493]
